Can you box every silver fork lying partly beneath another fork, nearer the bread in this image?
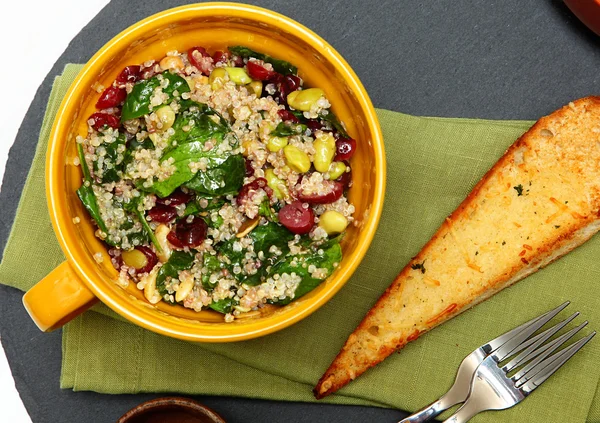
[398,301,575,423]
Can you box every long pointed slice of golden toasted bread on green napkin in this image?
[314,97,600,398]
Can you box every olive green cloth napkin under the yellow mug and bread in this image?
[0,65,600,423]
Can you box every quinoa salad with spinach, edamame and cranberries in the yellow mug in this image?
[73,46,356,322]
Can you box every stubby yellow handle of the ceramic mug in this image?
[23,261,98,332]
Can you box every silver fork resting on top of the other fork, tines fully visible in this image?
[444,313,596,423]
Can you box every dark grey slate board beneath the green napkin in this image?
[0,0,600,423]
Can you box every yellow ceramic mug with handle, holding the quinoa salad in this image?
[23,3,385,342]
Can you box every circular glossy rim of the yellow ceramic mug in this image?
[46,2,386,342]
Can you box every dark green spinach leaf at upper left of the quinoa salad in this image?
[121,72,190,122]
